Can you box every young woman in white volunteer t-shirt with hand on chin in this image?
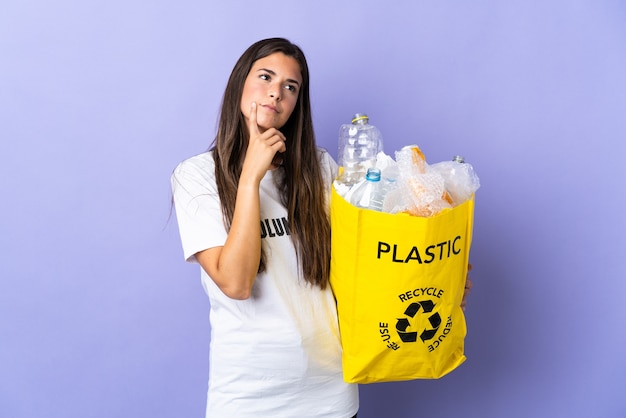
[172,38,358,418]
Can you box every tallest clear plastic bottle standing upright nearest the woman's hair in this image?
[337,113,383,187]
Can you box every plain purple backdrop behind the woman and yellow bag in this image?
[0,0,626,418]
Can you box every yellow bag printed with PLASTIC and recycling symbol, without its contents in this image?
[330,189,474,383]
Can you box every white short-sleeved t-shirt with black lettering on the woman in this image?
[172,149,358,418]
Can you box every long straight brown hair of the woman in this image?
[211,38,330,289]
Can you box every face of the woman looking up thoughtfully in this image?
[241,52,302,132]
